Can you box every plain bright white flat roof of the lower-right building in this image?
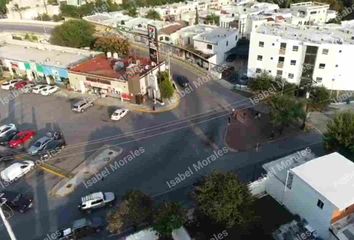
[291,152,354,210]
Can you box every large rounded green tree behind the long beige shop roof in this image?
[50,20,95,48]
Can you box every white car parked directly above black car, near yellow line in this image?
[0,160,34,182]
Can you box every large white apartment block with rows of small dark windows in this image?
[247,24,354,91]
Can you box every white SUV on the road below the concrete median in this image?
[78,192,115,211]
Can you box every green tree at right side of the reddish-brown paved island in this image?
[269,95,306,134]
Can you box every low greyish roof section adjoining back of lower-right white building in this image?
[263,149,316,184]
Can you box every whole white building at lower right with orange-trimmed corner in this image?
[263,152,354,240]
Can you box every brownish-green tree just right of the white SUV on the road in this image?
[107,191,153,233]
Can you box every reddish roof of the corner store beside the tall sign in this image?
[70,55,152,80]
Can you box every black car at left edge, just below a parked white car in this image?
[0,191,33,213]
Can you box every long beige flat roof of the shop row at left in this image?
[0,43,94,68]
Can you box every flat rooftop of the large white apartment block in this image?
[256,23,354,44]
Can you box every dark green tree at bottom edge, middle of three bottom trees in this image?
[152,203,187,238]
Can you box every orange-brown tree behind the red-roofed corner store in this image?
[94,36,130,56]
